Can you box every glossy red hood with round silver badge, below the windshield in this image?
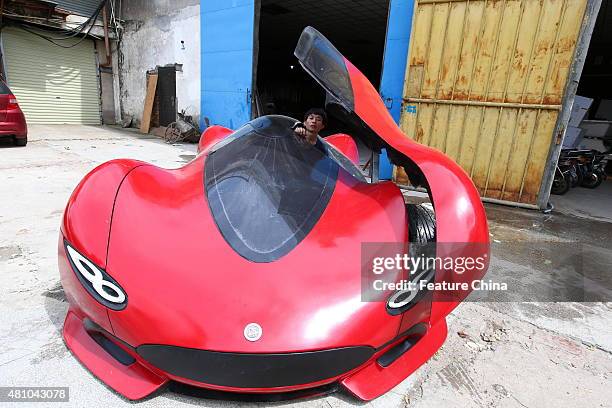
[107,155,407,352]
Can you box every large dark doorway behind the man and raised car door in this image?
[253,0,389,135]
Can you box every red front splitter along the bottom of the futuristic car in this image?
[63,311,447,401]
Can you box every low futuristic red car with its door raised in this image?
[58,27,489,400]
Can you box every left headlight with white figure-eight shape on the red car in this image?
[64,241,127,310]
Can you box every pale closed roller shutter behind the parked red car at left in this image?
[2,27,100,125]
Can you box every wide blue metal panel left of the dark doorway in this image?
[200,0,255,129]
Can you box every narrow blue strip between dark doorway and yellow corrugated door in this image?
[379,0,414,180]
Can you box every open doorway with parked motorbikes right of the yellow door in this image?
[550,0,612,222]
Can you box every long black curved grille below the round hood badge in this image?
[136,344,375,388]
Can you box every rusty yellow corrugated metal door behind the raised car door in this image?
[396,0,587,204]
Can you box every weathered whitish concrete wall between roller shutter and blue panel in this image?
[119,0,200,126]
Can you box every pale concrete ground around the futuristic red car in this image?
[0,126,612,408]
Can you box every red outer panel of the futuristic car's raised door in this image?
[345,60,489,324]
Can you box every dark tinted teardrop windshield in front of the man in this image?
[204,116,365,262]
